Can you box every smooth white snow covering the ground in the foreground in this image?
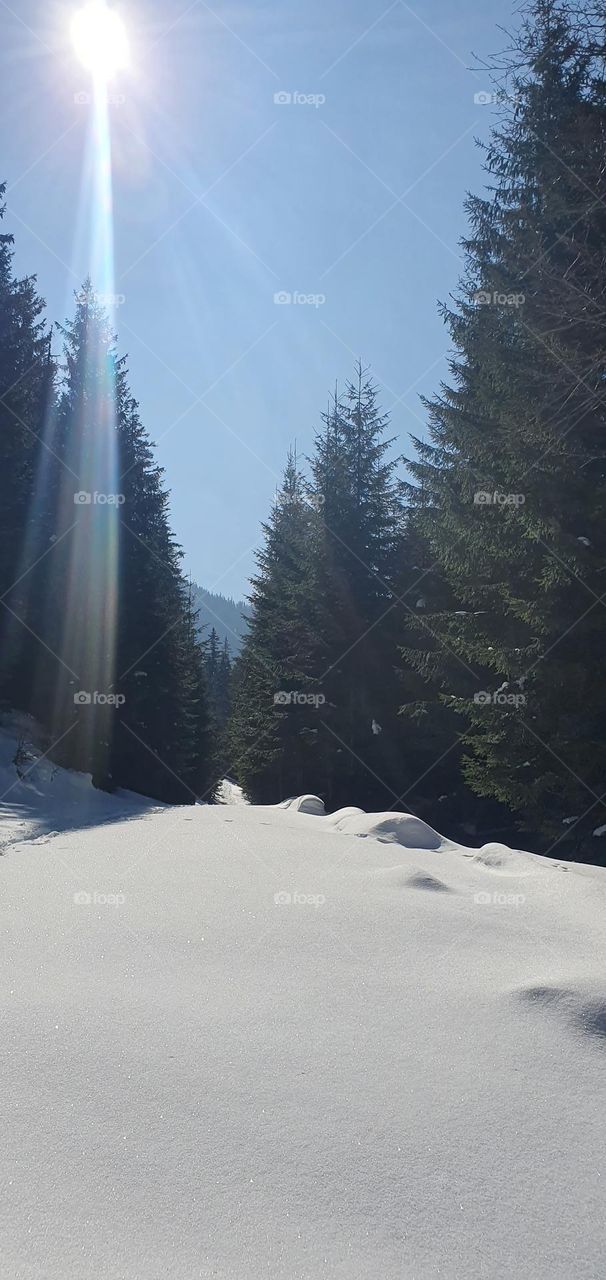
[0,747,606,1280]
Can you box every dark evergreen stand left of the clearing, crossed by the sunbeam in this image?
[0,234,224,804]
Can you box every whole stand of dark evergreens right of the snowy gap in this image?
[229,0,606,860]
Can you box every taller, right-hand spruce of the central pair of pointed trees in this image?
[309,364,404,808]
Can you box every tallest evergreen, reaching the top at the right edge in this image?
[404,0,606,854]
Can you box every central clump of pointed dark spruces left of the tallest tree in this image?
[231,366,405,808]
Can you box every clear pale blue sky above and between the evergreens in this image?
[0,0,512,596]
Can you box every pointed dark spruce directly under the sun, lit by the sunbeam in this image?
[38,282,209,803]
